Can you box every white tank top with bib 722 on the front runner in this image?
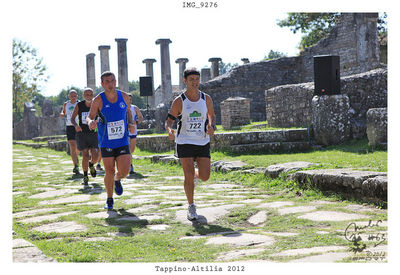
[175,92,210,145]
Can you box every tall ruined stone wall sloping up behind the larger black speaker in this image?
[200,13,380,123]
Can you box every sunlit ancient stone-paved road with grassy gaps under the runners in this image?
[13,146,387,262]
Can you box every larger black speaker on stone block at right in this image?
[314,55,340,95]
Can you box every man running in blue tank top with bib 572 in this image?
[87,71,135,210]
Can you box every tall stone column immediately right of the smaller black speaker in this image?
[156,38,172,104]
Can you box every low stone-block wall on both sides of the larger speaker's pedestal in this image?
[265,68,387,138]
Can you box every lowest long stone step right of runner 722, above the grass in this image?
[230,141,311,153]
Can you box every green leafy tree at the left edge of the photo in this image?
[12,39,49,122]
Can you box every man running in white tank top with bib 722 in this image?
[165,68,216,220]
